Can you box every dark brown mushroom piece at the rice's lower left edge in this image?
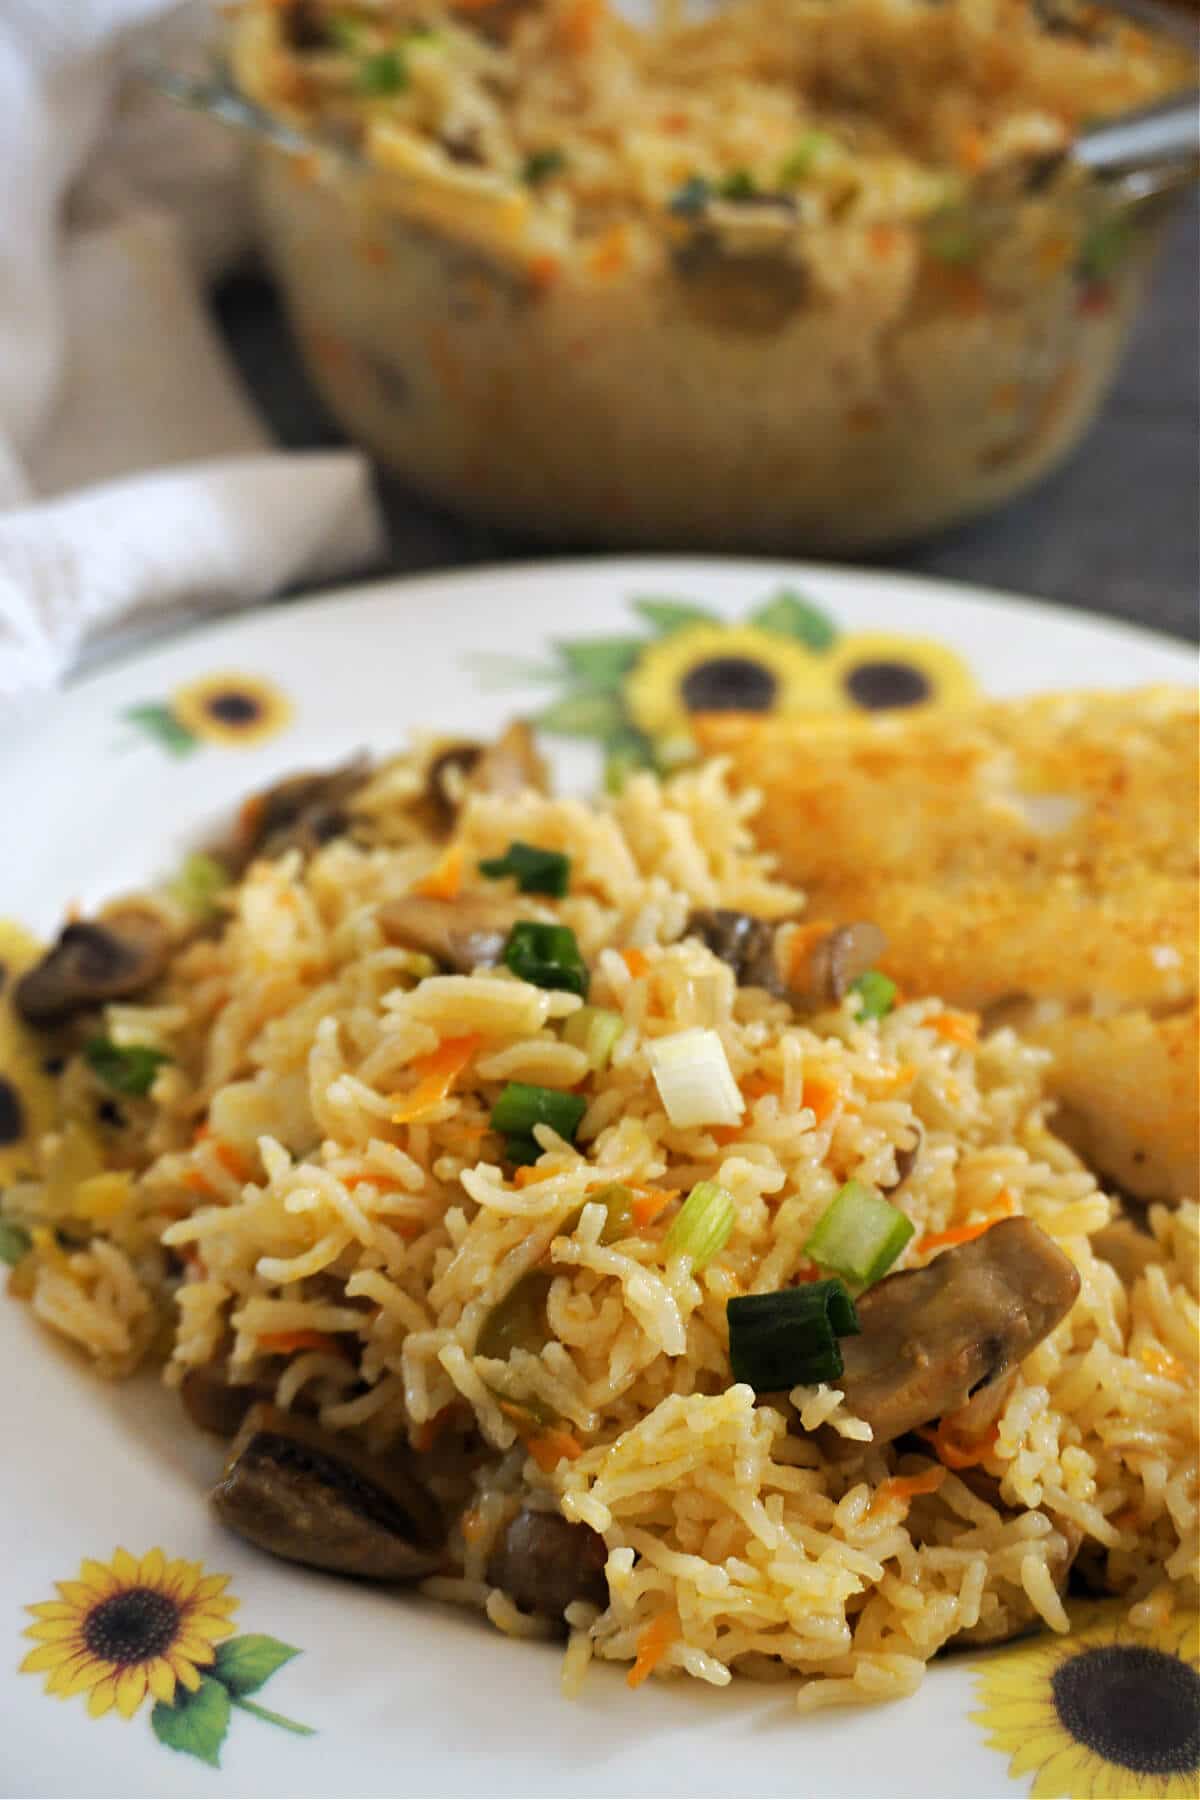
[212,1404,444,1580]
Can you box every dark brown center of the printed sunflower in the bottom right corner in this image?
[1051,1643,1200,1775]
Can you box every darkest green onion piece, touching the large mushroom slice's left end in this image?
[725,1280,862,1393]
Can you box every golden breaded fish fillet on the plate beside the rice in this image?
[696,686,1200,1195]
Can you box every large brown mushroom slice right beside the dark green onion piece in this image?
[838,1219,1079,1444]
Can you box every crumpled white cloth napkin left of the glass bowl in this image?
[0,0,381,724]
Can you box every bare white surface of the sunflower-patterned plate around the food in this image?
[0,558,1193,1796]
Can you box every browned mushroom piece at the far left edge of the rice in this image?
[13,900,171,1031]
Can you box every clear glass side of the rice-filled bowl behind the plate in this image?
[154,7,1194,553]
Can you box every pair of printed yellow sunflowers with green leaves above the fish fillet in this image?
[473,589,975,785]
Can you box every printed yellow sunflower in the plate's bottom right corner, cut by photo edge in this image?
[972,1606,1200,1800]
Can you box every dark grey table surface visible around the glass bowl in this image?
[214,195,1200,639]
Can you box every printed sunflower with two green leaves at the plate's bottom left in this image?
[22,1550,313,1768]
